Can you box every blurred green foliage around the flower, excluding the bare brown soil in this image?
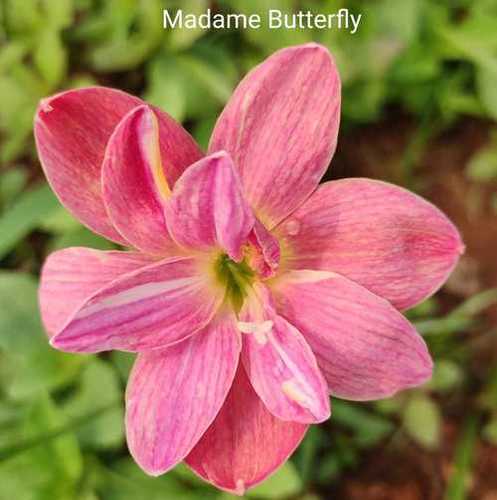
[0,0,497,500]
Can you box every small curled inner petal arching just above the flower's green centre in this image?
[166,152,254,261]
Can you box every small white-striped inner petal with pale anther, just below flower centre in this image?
[238,286,330,423]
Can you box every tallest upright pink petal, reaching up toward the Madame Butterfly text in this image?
[209,43,340,229]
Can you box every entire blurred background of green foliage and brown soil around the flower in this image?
[0,0,497,500]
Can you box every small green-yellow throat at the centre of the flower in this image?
[216,254,255,312]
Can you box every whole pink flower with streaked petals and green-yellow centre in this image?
[35,44,463,494]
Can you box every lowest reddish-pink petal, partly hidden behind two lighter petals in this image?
[186,367,307,495]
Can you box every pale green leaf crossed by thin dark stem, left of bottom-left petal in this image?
[64,358,124,449]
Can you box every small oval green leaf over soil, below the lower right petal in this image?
[403,394,442,450]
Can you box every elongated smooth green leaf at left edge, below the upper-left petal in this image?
[0,184,59,259]
